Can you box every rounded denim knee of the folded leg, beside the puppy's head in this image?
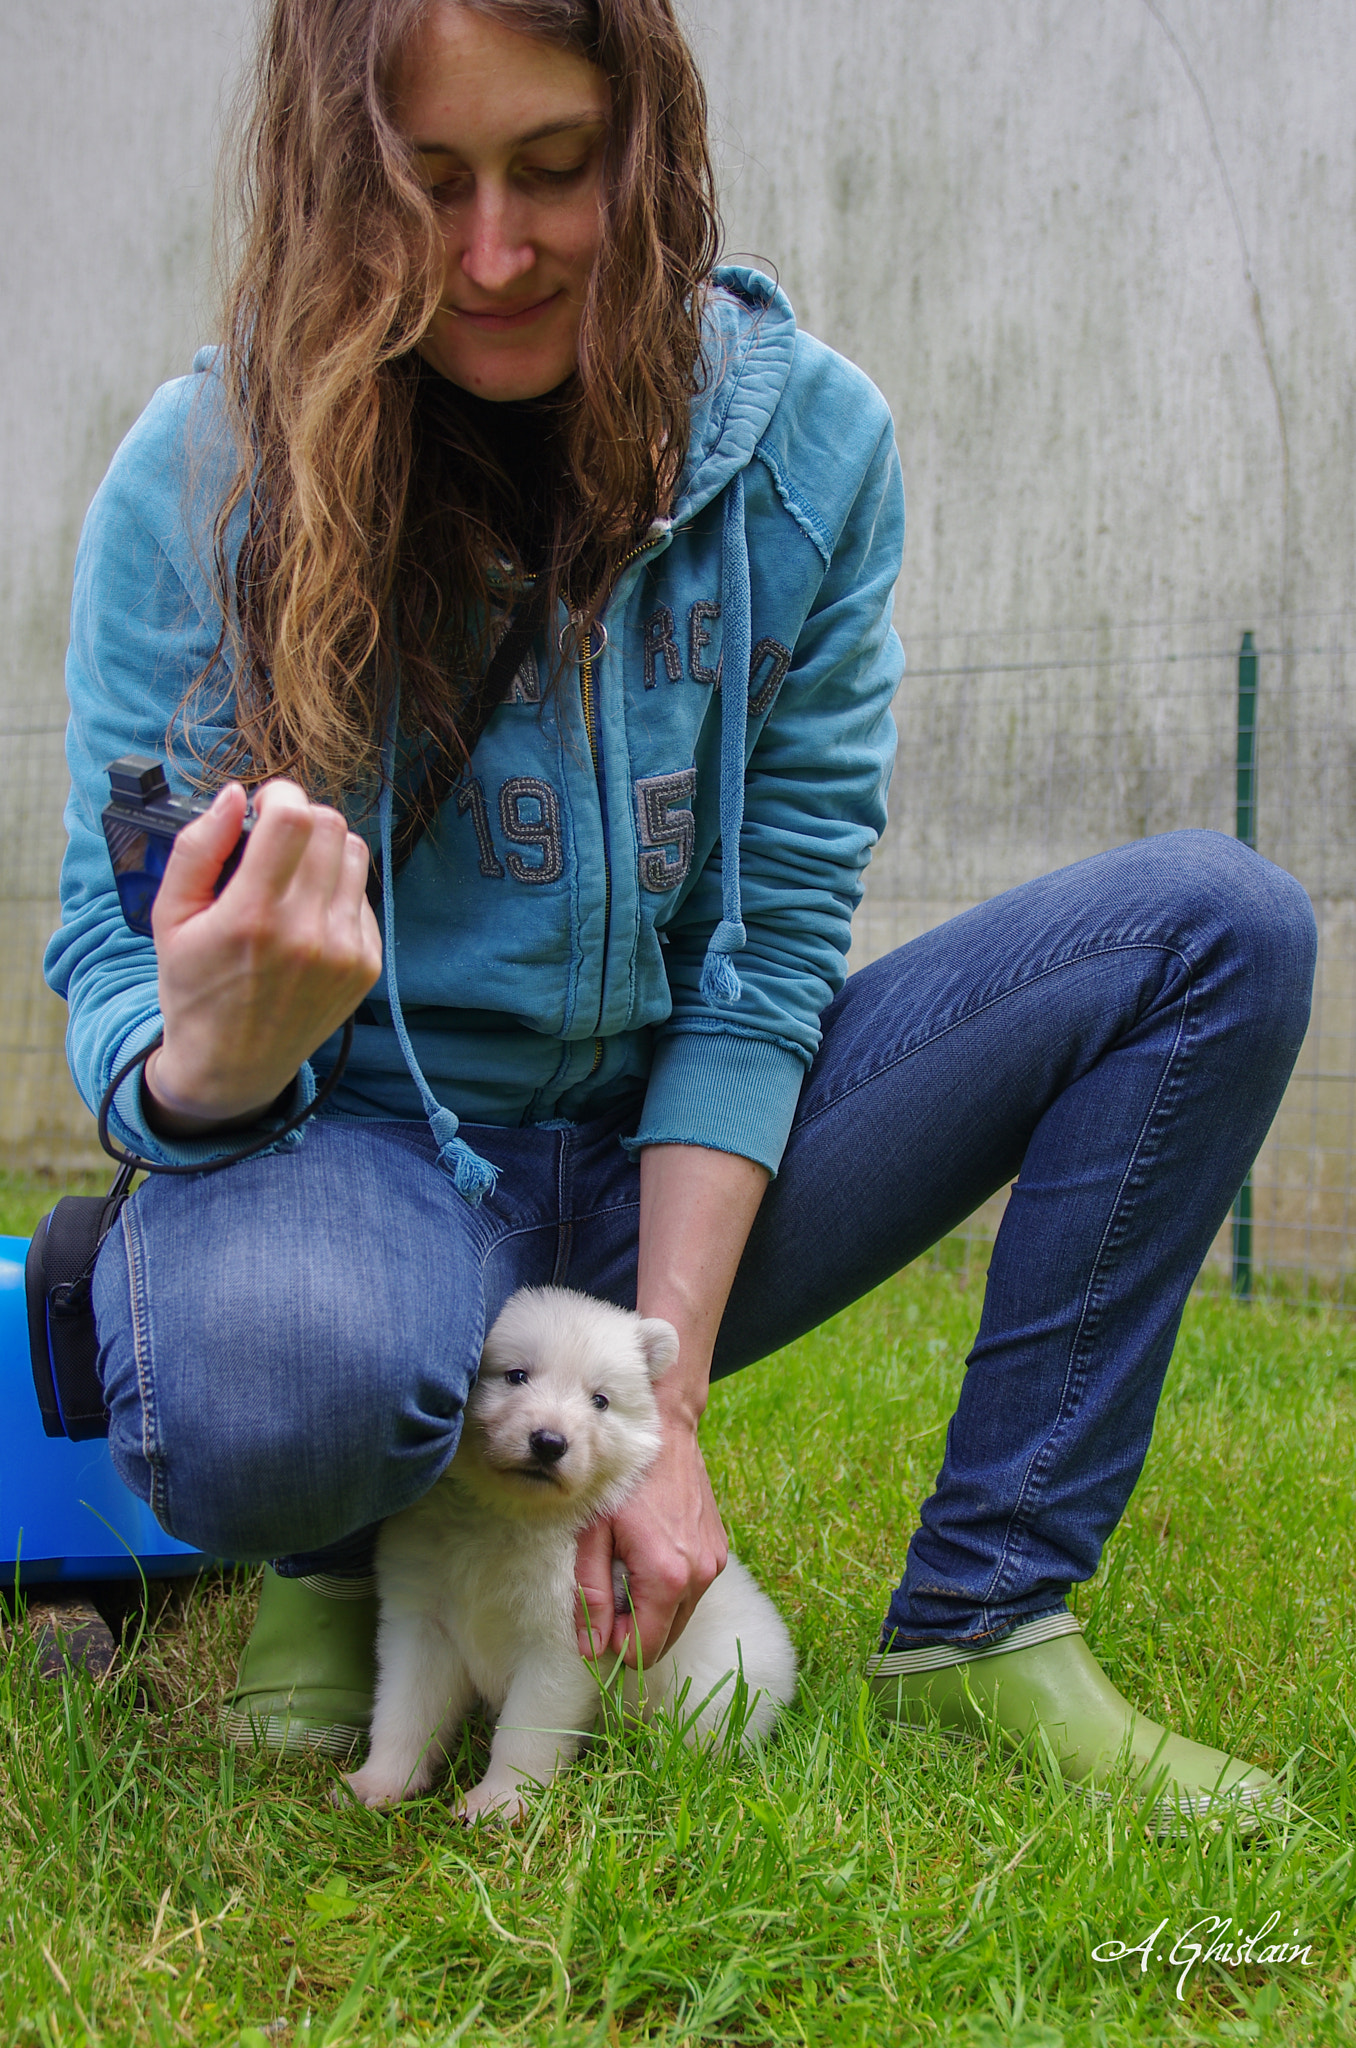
[94,1120,493,1559]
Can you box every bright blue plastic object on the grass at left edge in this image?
[0,1237,209,1585]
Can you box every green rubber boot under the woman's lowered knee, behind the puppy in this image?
[219,1567,377,1757]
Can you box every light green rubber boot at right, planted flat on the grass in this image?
[866,1614,1284,1835]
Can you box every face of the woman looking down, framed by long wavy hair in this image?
[395,0,610,399]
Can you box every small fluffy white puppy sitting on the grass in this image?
[348,1288,795,1819]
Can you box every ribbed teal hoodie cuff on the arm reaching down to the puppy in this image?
[623,1026,805,1176]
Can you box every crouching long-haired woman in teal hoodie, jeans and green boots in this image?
[49,0,1313,1812]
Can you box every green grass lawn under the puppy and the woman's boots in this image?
[0,1268,1356,2048]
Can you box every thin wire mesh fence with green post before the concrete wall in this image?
[0,610,1356,1307]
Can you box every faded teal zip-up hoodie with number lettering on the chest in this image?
[45,268,903,1192]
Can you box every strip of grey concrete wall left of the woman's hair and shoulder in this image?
[0,0,258,1167]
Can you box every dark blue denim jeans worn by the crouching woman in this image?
[94,831,1315,1642]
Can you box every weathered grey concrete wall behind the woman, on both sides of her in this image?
[0,0,1356,1257]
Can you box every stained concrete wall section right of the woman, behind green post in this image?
[688,0,1356,1280]
